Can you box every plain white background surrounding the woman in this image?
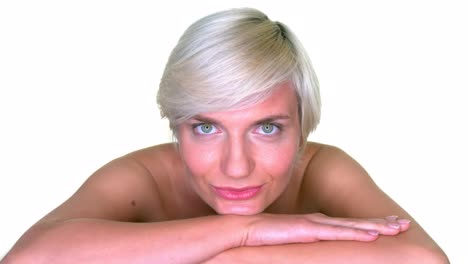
[0,0,468,263]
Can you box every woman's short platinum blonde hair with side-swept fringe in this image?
[157,8,320,142]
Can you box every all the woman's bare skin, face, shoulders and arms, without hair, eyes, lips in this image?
[2,87,448,263]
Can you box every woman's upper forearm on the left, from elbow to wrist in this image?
[5,216,246,263]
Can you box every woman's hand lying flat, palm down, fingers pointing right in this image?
[241,213,410,246]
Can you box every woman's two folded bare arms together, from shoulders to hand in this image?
[2,145,448,264]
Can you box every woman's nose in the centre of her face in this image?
[221,137,255,178]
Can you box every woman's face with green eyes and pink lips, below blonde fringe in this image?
[177,83,300,215]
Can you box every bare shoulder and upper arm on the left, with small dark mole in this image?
[40,145,181,225]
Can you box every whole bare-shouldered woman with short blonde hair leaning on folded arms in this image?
[3,9,448,263]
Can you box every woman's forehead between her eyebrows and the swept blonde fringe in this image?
[198,82,298,120]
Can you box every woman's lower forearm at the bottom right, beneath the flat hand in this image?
[204,234,449,264]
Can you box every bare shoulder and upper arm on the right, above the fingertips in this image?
[302,143,398,217]
